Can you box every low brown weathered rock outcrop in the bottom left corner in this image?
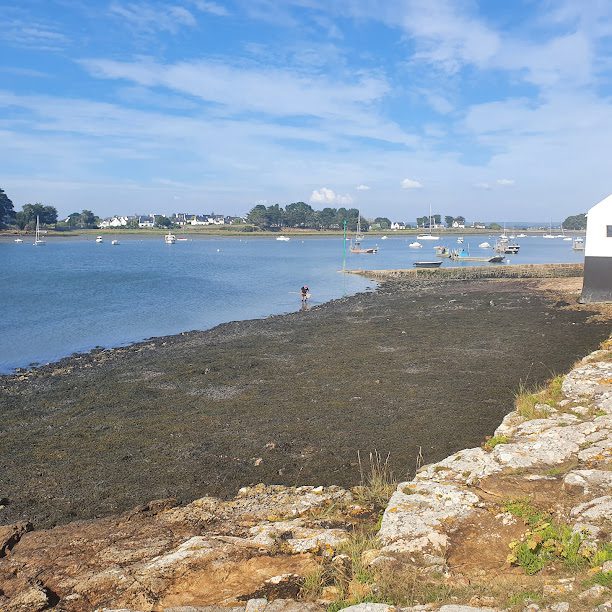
[0,485,352,611]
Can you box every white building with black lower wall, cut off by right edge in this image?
[581,195,612,303]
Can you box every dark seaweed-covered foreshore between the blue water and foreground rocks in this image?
[0,279,610,526]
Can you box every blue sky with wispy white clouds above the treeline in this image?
[0,0,612,221]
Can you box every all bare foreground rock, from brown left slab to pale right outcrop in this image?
[0,342,612,612]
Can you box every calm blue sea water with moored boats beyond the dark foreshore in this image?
[0,235,583,372]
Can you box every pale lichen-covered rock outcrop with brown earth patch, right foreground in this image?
[373,344,612,610]
